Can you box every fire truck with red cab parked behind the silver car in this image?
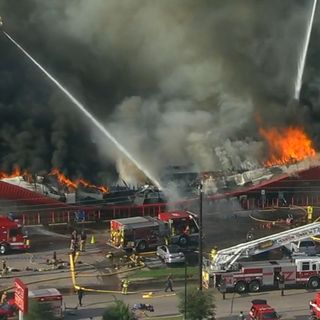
[110,211,199,252]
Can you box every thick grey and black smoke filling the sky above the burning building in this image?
[0,0,320,182]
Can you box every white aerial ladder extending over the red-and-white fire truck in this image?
[204,222,320,273]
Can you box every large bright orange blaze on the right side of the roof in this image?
[259,127,316,166]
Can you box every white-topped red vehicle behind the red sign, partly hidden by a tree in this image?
[28,288,63,319]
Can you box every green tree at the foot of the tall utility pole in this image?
[179,287,216,320]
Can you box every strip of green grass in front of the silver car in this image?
[130,267,199,279]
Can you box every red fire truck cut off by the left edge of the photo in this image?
[0,216,30,254]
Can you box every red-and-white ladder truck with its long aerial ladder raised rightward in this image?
[204,222,320,293]
